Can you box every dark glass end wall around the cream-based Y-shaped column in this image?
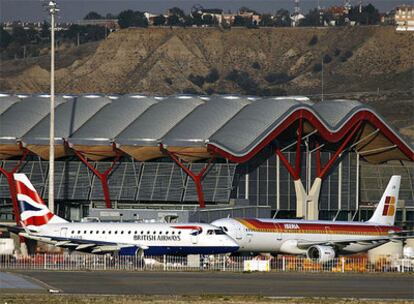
[233,152,356,214]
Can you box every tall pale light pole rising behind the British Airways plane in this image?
[48,0,59,213]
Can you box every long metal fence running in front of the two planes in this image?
[0,254,414,272]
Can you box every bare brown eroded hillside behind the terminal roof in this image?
[0,27,414,141]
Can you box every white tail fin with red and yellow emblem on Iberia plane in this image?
[368,175,401,225]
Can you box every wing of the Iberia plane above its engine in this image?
[297,233,414,249]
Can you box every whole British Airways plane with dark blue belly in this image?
[4,173,239,255]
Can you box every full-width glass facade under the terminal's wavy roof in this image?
[0,156,414,221]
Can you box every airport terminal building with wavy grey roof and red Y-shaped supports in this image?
[0,94,414,227]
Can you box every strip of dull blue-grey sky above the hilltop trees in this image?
[0,0,413,22]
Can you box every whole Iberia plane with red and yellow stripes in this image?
[211,176,413,262]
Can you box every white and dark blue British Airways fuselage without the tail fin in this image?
[34,222,238,255]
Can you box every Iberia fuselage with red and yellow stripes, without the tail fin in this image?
[211,218,401,254]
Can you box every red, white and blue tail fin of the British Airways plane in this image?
[13,173,67,228]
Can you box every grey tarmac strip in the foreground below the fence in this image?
[4,271,414,300]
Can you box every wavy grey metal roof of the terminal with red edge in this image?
[0,94,414,163]
